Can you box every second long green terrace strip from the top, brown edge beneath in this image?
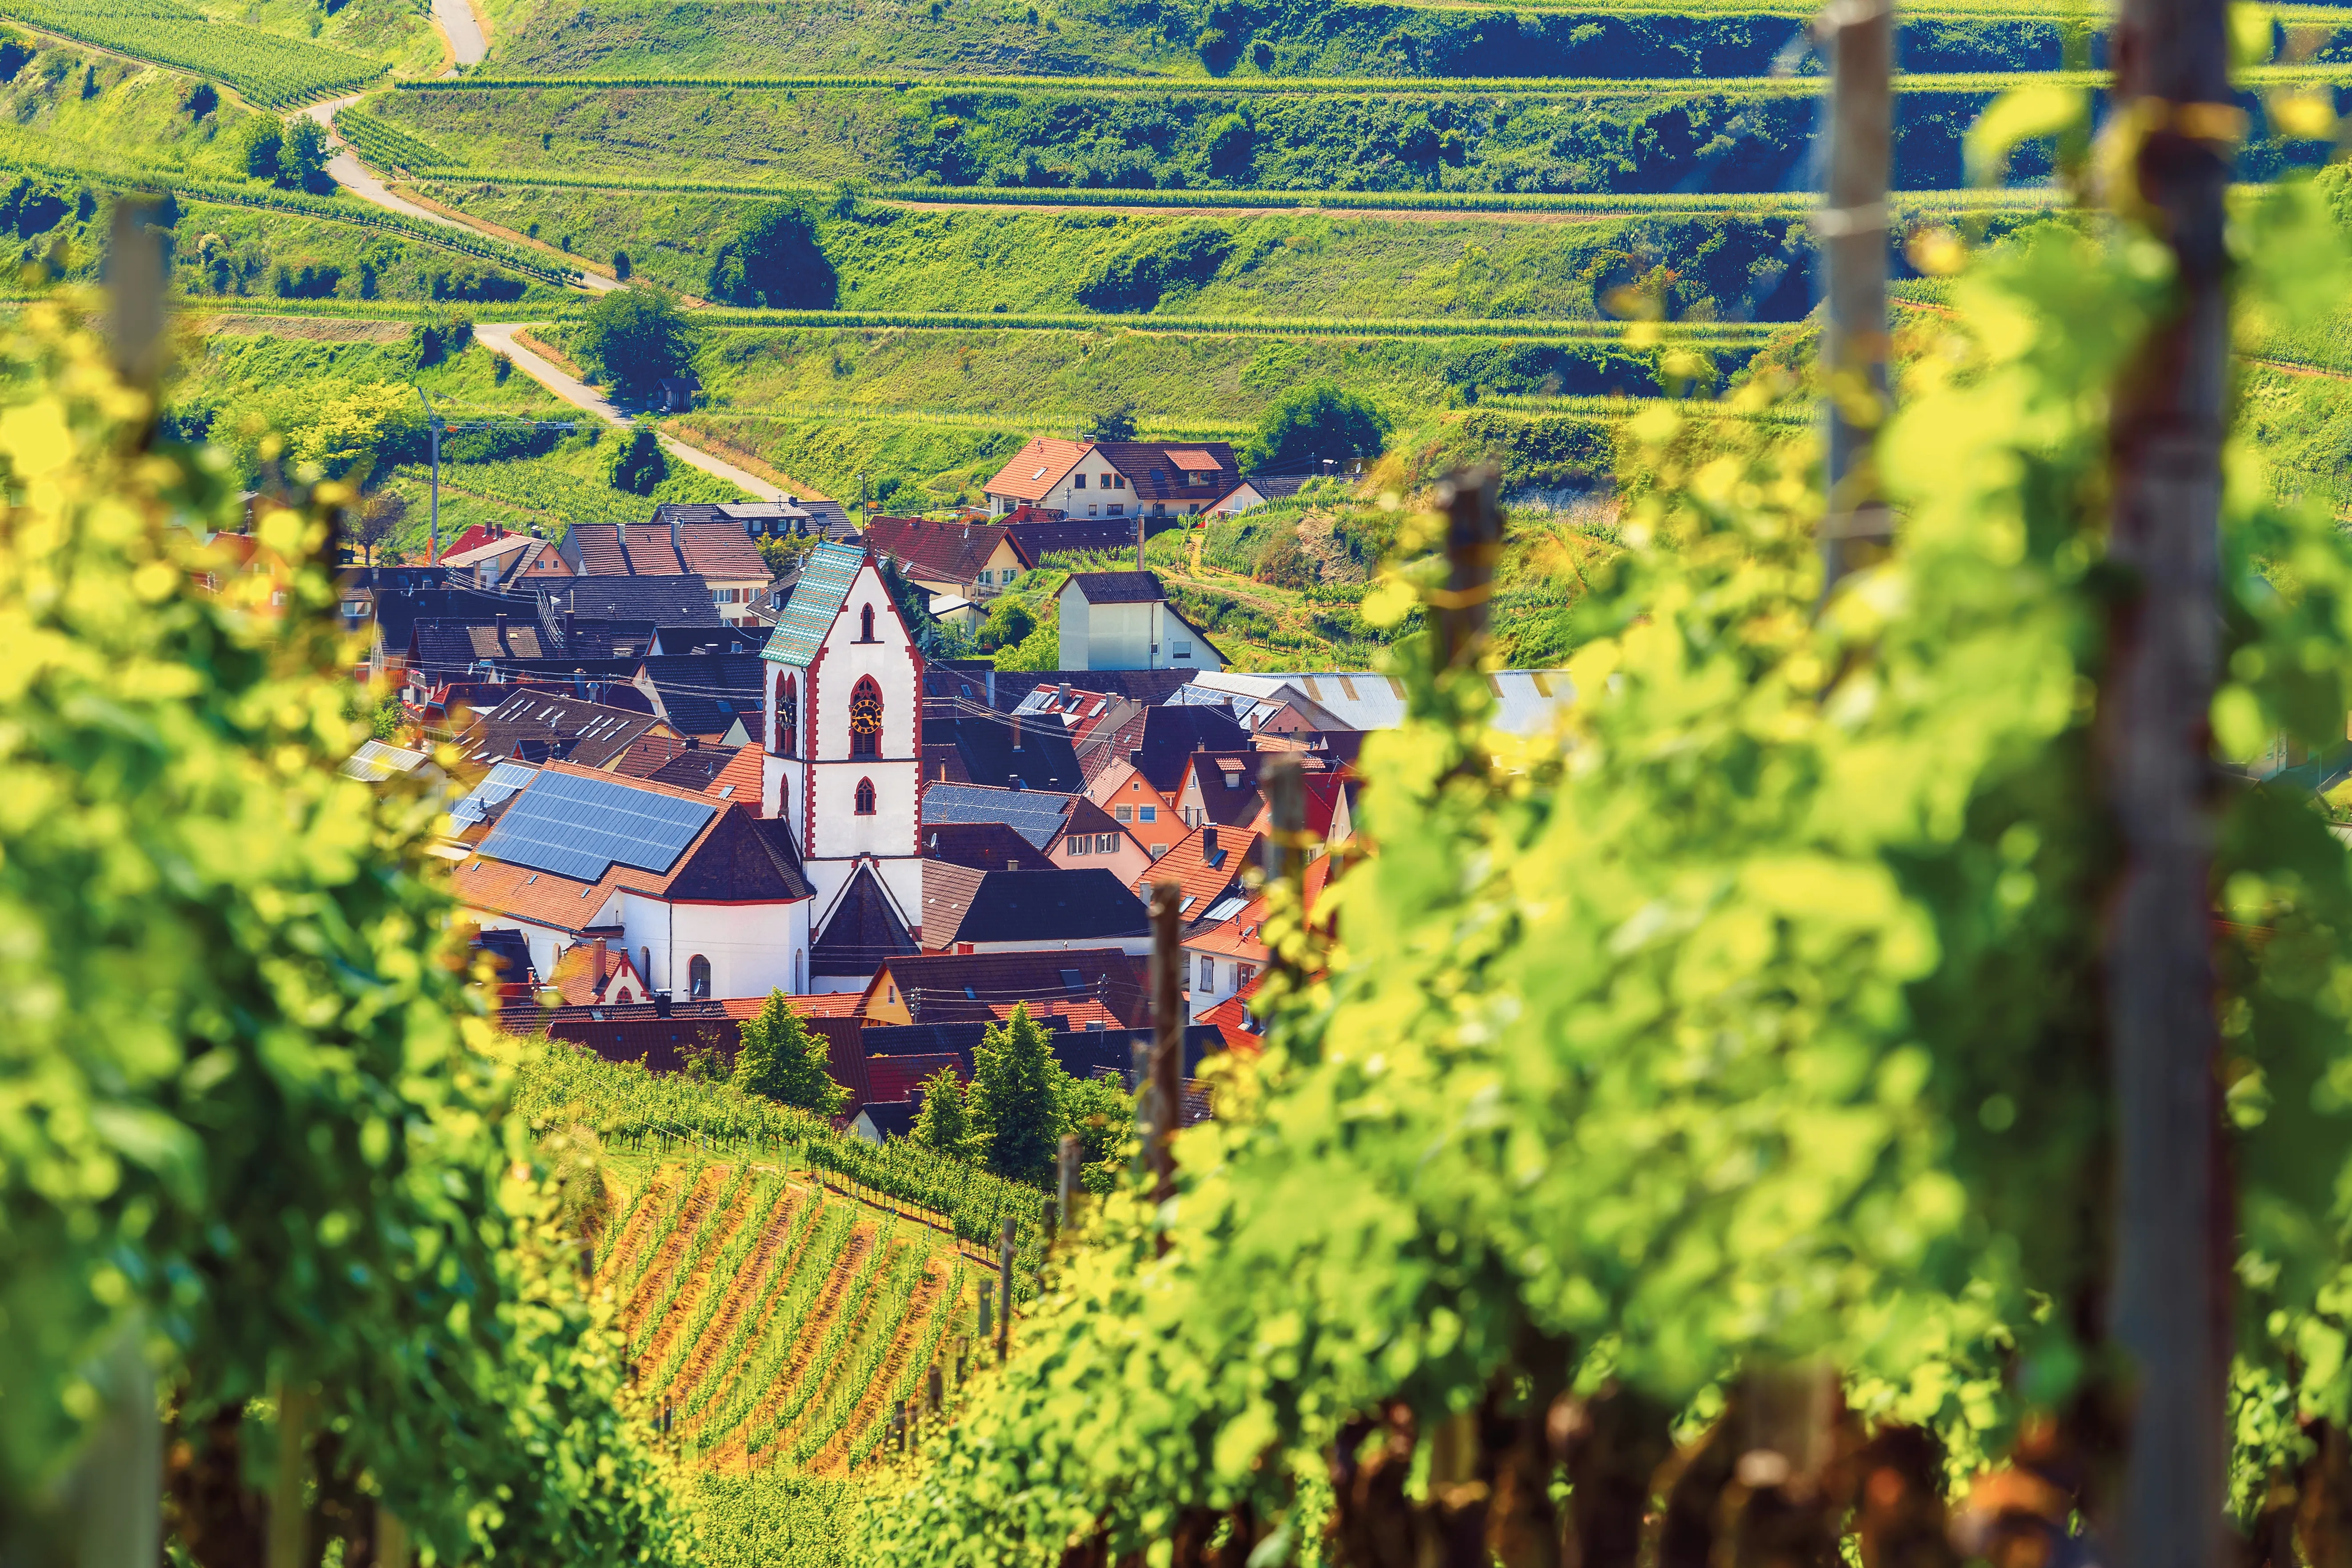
[395,164,2065,219]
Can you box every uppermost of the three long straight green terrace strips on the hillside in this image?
[393,64,2352,101]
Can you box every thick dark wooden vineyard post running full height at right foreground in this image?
[2098,0,2246,1568]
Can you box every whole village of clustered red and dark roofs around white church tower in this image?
[322,440,1569,1140]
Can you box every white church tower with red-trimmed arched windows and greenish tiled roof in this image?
[760,543,922,980]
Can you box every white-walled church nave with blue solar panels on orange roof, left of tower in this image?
[452,762,814,999]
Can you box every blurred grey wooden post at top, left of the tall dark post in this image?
[1813,0,1896,592]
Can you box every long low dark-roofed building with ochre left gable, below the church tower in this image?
[859,948,1152,1030]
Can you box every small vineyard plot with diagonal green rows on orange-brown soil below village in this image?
[597,1161,981,1476]
